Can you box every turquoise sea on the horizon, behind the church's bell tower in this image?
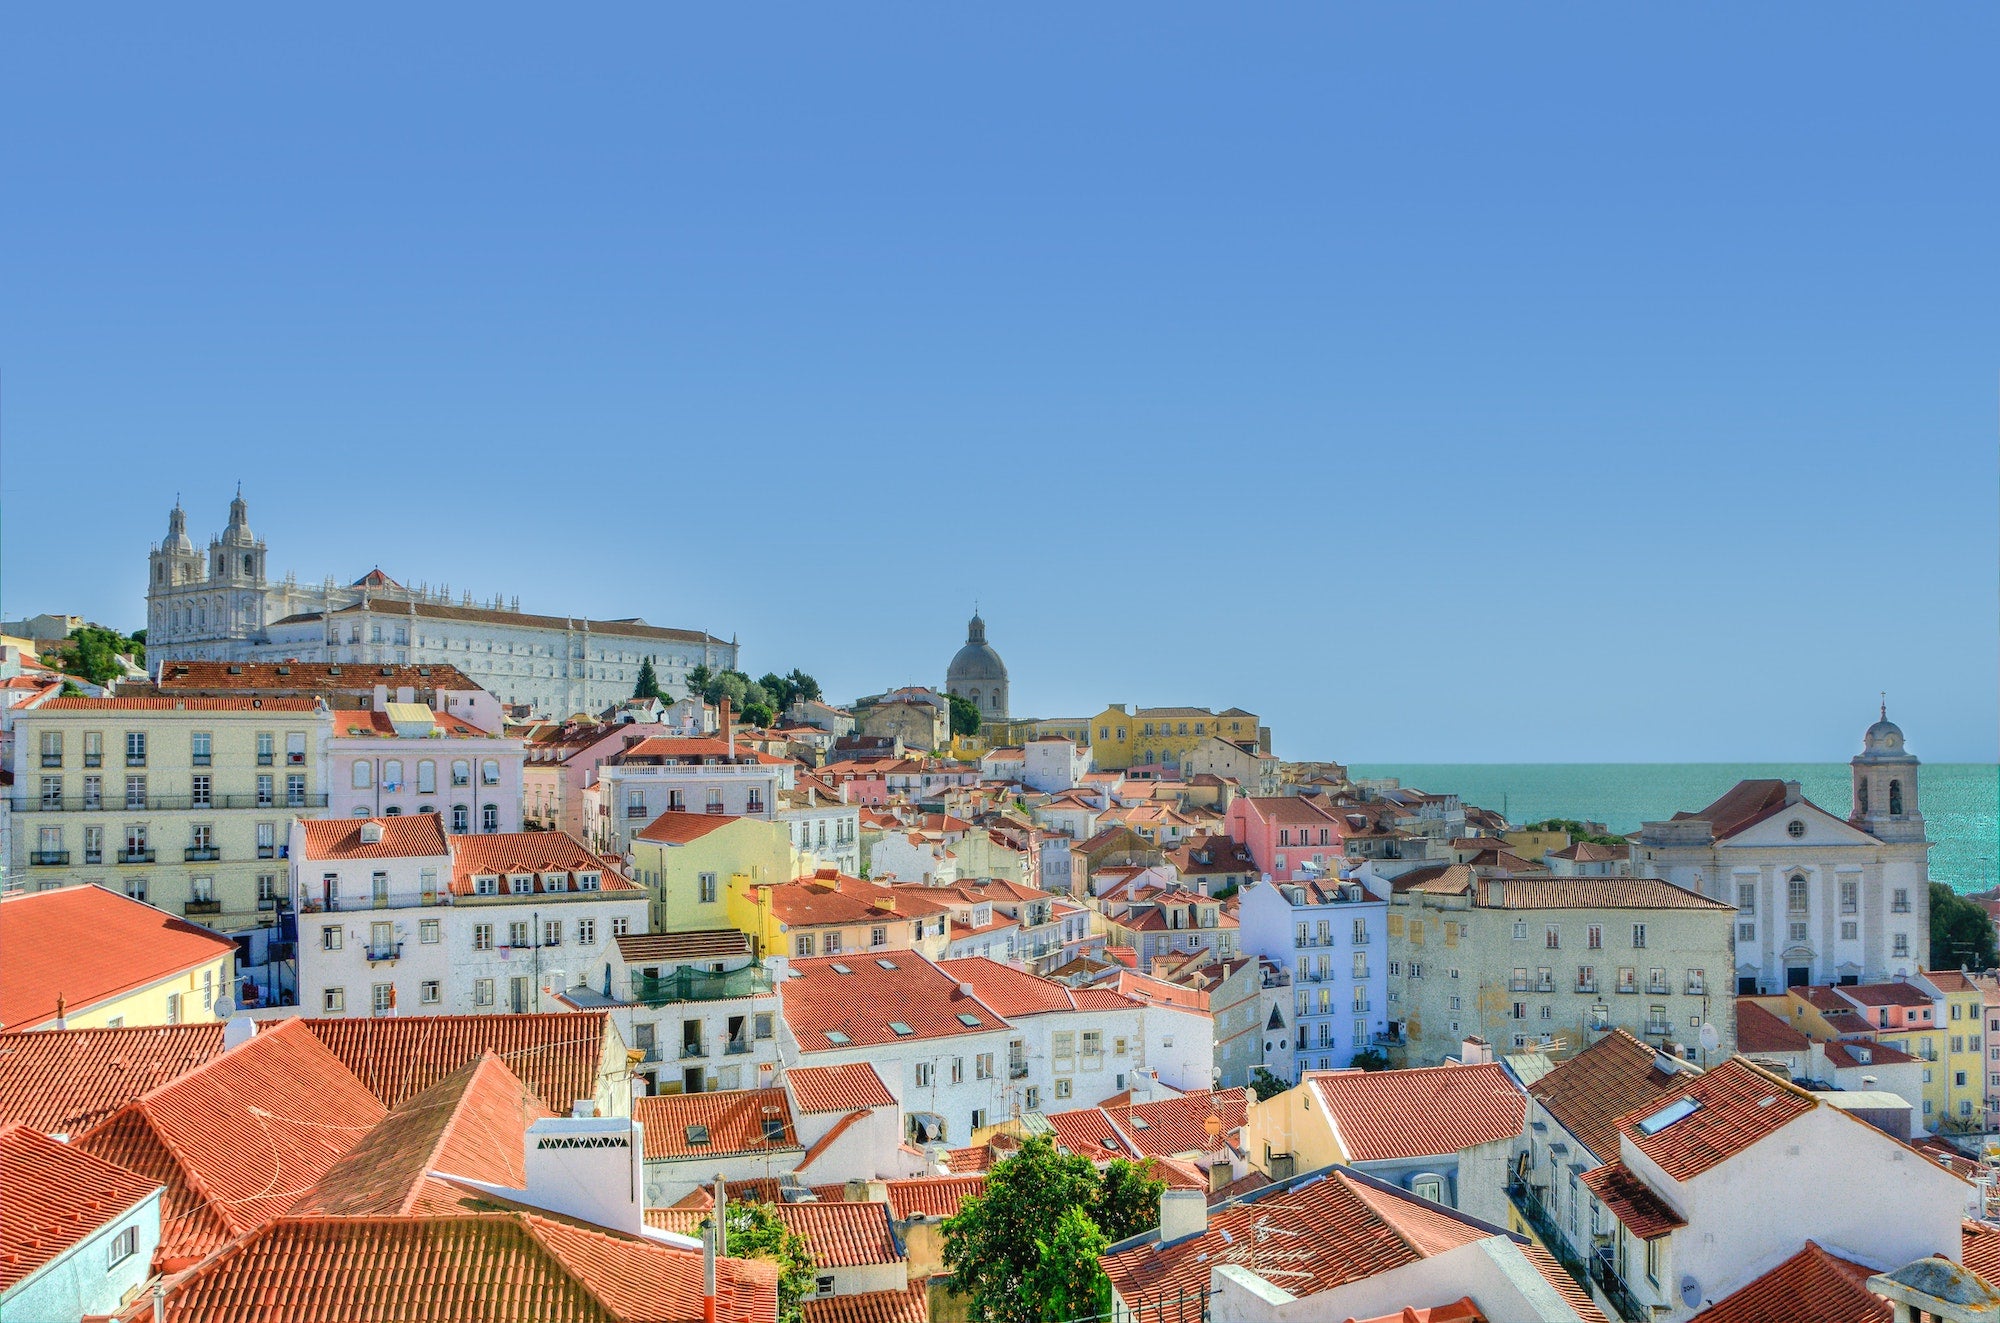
[1348,763,2000,891]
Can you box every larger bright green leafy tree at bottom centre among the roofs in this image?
[944,1135,1100,1323]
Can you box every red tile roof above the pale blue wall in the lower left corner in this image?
[0,1123,158,1293]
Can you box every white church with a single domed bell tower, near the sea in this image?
[1632,699,1930,995]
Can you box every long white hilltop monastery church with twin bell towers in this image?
[146,488,736,717]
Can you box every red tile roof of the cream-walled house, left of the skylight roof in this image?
[1306,1061,1528,1163]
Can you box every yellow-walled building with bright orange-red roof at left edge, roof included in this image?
[0,887,236,1029]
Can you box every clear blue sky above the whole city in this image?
[0,4,2000,761]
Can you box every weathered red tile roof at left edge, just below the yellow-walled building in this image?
[0,1023,222,1135]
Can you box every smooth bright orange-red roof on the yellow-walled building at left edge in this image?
[0,885,236,1029]
